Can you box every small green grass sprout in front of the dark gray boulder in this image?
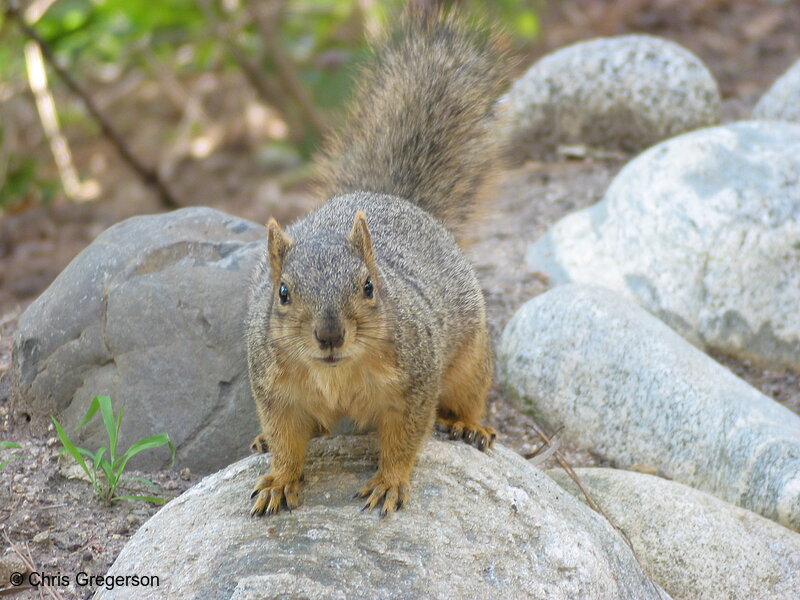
[51,396,175,504]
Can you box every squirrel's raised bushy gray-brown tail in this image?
[314,11,510,229]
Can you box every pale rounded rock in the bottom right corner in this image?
[547,469,800,600]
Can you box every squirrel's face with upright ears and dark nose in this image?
[267,211,388,367]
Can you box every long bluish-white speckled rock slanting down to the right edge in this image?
[498,284,800,530]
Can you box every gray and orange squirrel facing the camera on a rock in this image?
[245,11,509,516]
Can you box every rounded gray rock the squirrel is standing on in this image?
[95,436,666,600]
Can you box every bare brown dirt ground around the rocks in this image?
[0,0,800,599]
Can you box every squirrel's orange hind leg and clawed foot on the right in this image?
[436,324,497,450]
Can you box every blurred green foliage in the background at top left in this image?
[0,0,542,211]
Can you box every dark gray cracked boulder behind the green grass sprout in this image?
[12,208,265,472]
